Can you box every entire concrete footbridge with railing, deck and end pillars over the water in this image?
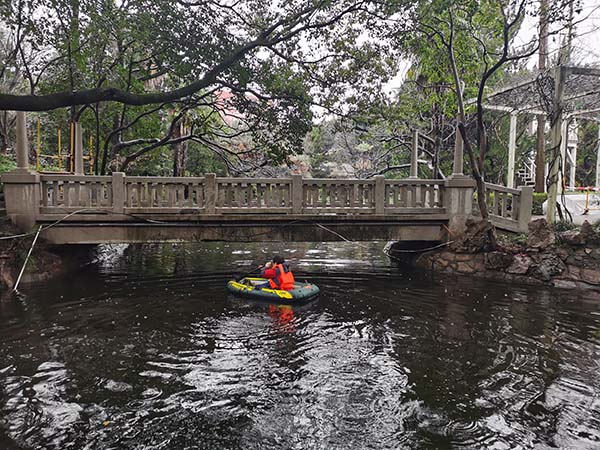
[2,113,532,244]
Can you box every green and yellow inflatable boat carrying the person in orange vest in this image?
[227,277,319,303]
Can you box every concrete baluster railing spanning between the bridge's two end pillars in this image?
[39,173,445,215]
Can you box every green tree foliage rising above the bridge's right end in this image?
[342,0,519,183]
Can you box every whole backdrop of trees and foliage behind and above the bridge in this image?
[0,0,596,183]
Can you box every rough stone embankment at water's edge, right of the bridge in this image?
[415,219,600,290]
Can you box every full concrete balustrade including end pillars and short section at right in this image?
[3,171,532,237]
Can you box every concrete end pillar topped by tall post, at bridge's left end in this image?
[2,112,40,231]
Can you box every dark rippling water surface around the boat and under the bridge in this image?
[0,244,600,450]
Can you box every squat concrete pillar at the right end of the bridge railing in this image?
[444,175,475,234]
